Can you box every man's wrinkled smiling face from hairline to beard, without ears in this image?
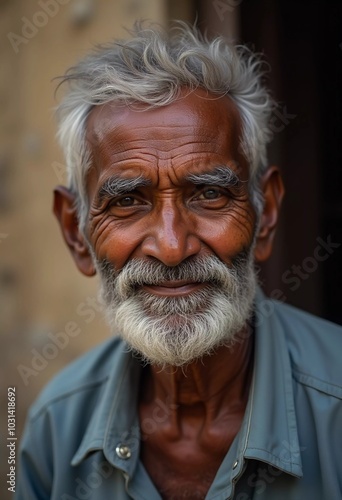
[86,91,256,365]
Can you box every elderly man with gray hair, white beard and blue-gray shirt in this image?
[18,24,342,500]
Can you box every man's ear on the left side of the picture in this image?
[53,186,96,276]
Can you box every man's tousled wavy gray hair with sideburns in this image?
[57,21,275,231]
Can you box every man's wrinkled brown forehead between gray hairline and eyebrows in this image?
[82,91,249,200]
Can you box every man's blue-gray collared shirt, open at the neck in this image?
[16,292,342,500]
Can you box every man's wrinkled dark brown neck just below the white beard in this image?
[141,326,253,426]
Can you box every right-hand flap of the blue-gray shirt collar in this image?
[240,289,303,477]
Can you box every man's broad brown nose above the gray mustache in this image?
[141,204,201,267]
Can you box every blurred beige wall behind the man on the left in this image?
[0,0,166,490]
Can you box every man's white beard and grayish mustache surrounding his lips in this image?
[95,249,257,366]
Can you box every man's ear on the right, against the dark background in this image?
[254,166,285,262]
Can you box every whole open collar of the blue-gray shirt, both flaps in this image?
[71,290,302,477]
